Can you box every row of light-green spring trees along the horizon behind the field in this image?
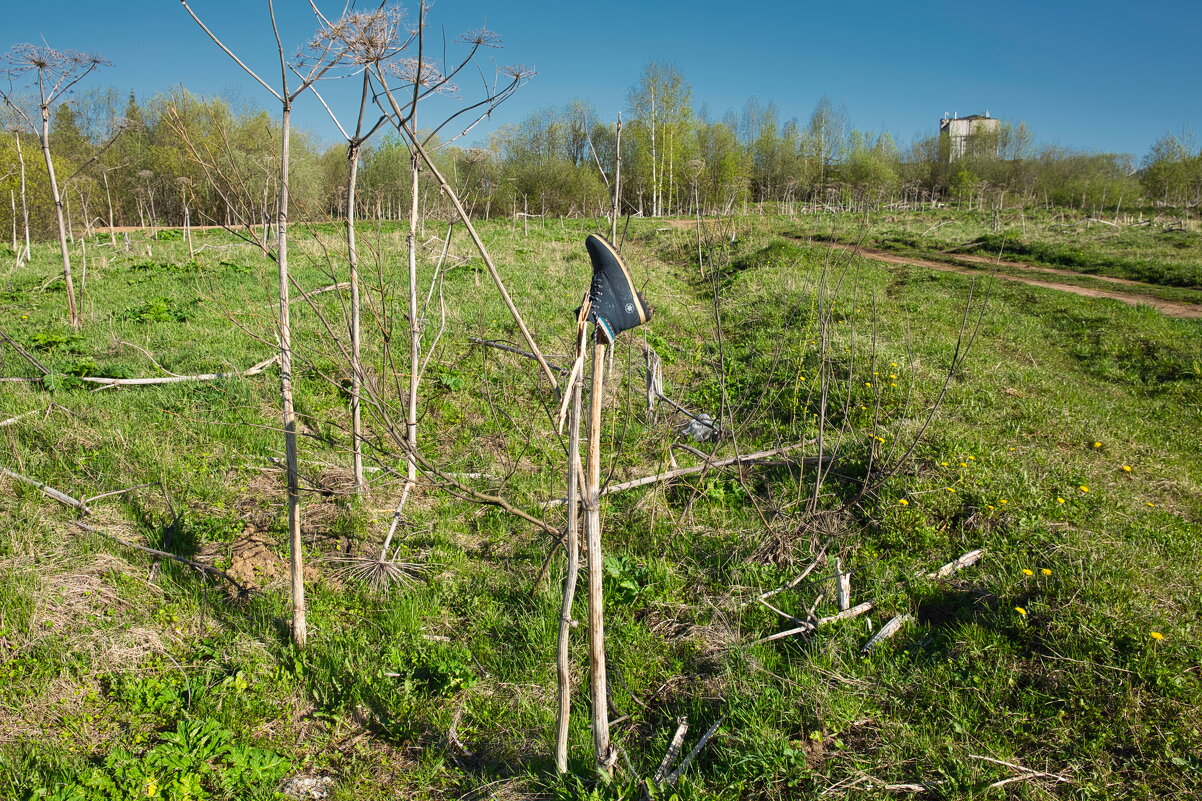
[0,63,1202,242]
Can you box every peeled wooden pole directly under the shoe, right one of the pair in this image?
[584,336,611,779]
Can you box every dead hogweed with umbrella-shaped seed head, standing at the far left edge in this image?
[0,45,109,328]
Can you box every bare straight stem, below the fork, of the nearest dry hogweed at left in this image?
[275,102,309,648]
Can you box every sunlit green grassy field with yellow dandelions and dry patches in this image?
[0,212,1202,801]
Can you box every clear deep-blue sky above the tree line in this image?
[0,0,1202,156]
